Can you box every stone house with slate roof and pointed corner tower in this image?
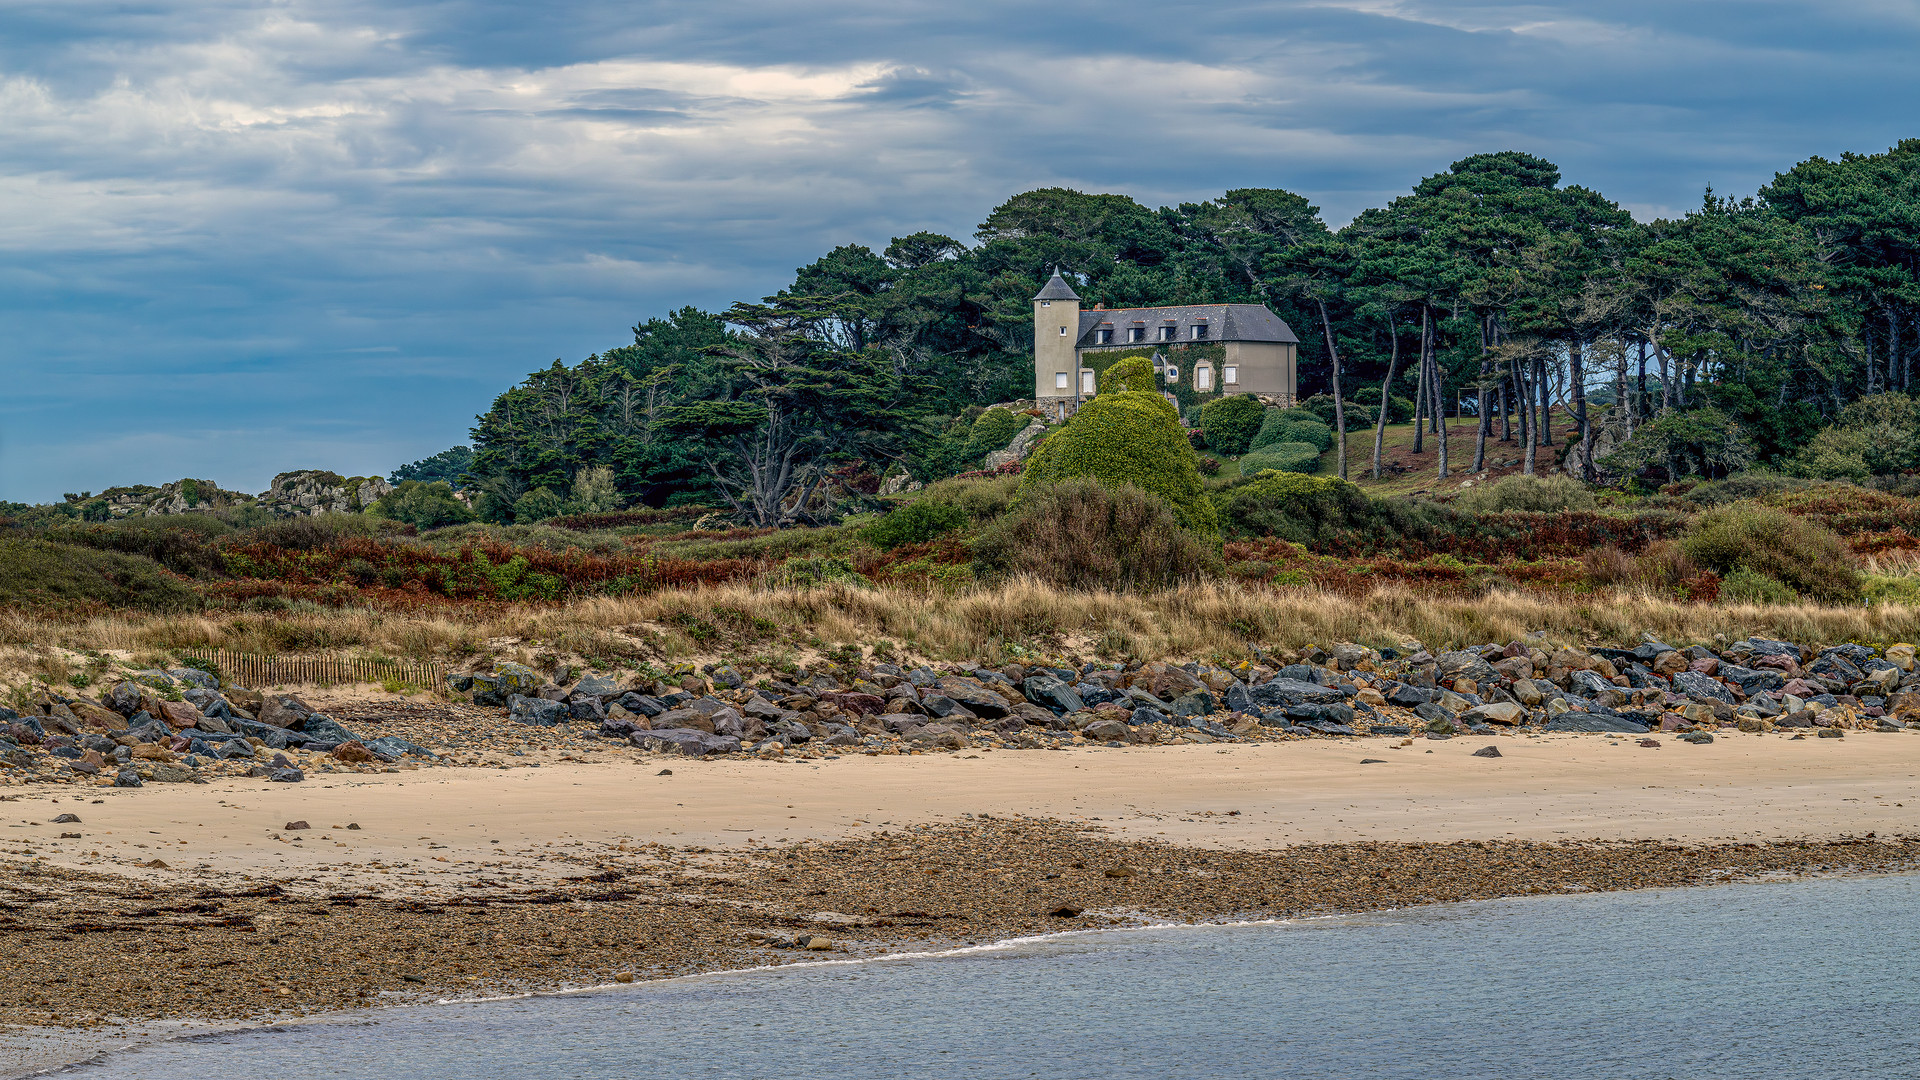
[1033,271,1300,411]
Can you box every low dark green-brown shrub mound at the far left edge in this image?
[0,540,200,611]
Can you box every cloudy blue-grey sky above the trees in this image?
[0,0,1920,502]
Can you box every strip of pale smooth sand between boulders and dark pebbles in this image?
[0,732,1920,888]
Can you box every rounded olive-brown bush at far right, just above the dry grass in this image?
[1680,503,1862,603]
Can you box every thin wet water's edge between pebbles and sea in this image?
[11,838,1920,1080]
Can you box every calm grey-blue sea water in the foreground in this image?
[63,874,1920,1080]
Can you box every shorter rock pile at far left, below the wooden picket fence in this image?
[0,669,432,788]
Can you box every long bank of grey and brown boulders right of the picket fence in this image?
[453,638,1920,757]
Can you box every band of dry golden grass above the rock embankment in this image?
[11,580,1920,671]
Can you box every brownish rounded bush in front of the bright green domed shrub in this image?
[973,477,1219,590]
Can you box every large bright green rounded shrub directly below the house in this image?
[1020,390,1219,536]
